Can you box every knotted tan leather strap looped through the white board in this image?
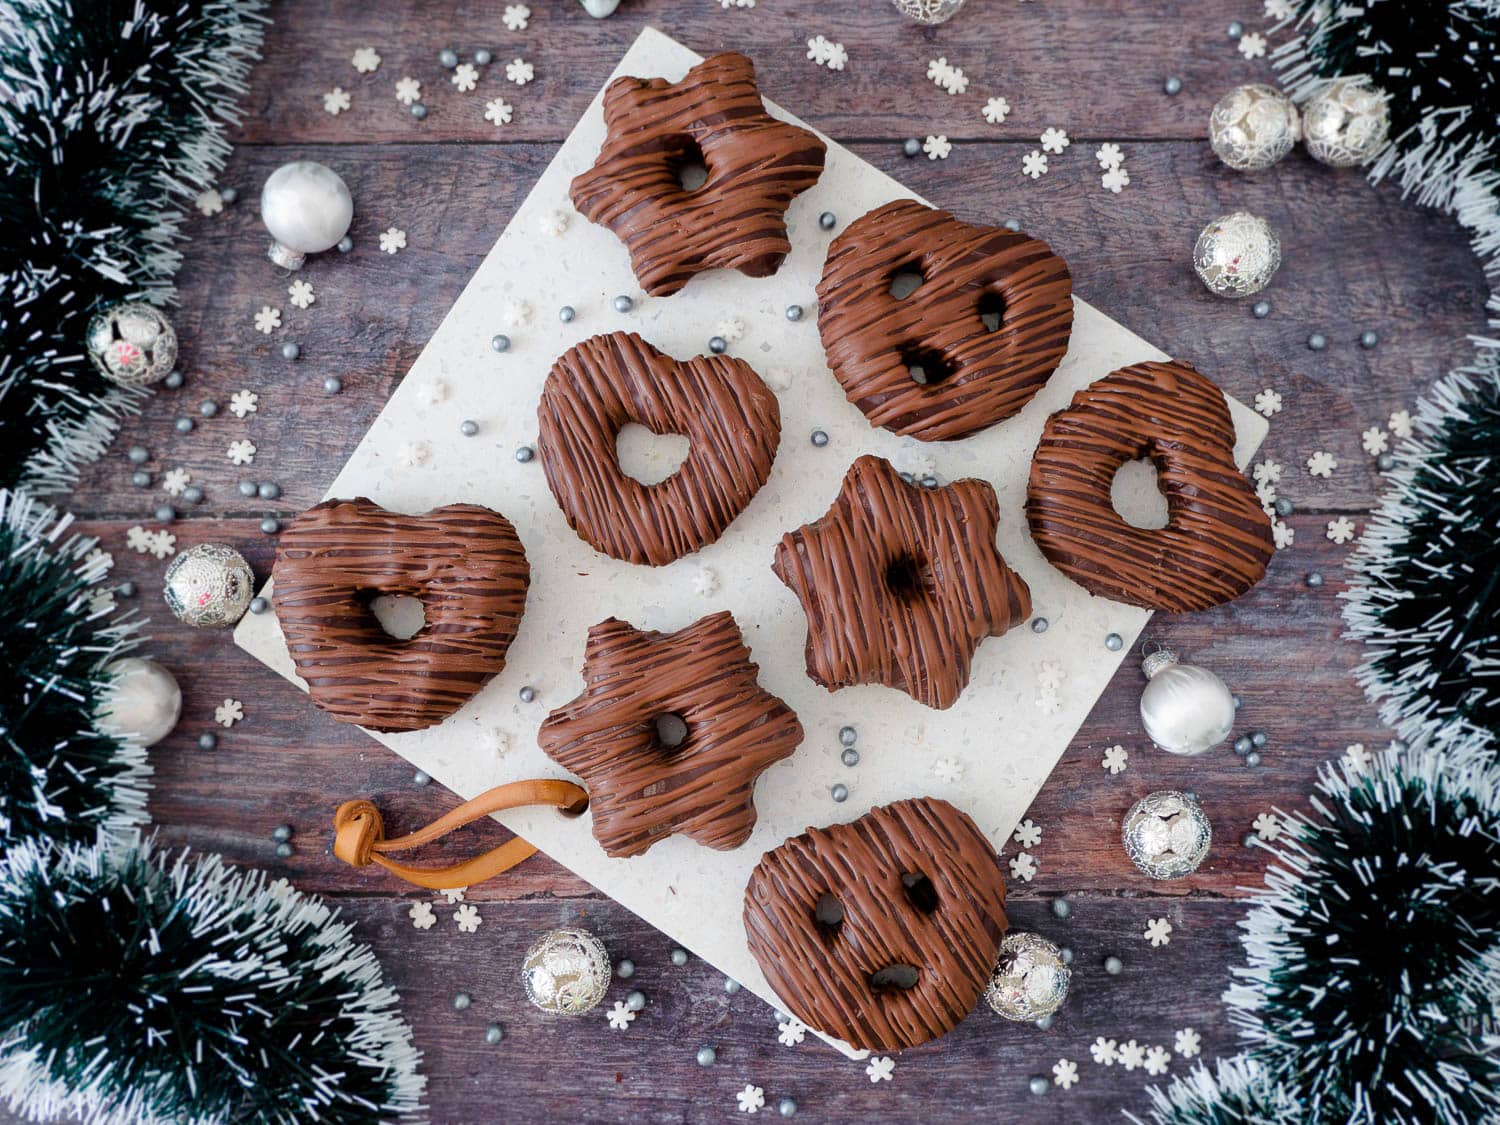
[333,780,588,891]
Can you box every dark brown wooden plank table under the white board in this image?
[55,0,1485,1122]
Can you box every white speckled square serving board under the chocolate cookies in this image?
[236,29,1266,1055]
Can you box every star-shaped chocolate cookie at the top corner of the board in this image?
[569,53,825,297]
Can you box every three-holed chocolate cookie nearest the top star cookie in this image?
[818,200,1073,441]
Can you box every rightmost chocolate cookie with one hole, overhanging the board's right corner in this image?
[1026,362,1274,614]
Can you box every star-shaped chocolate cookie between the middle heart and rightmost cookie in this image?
[773,456,1031,710]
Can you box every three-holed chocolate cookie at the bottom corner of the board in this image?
[744,797,1007,1052]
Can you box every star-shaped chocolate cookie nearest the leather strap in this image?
[537,612,803,857]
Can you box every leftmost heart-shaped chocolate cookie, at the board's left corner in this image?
[272,498,531,731]
